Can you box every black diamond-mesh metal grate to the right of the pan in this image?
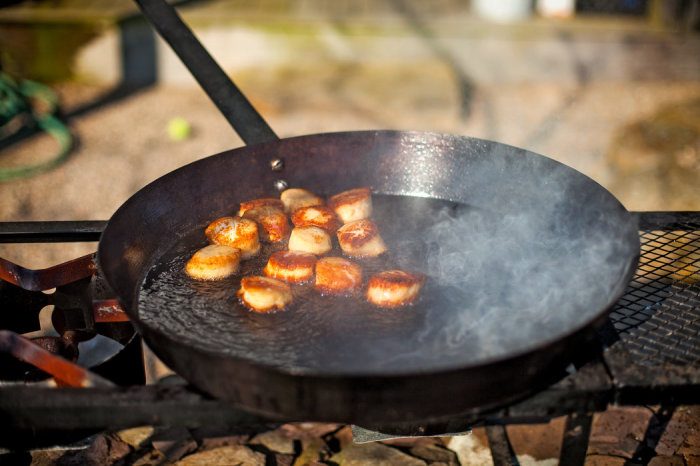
[610,223,700,365]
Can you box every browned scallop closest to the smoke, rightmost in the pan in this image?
[367,270,425,308]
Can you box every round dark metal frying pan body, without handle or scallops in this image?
[98,1,639,424]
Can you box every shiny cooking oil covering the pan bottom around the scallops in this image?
[139,195,636,375]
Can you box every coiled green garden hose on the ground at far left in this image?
[0,71,73,182]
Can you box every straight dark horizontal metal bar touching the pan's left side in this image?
[0,220,107,243]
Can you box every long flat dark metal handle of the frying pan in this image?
[135,0,279,145]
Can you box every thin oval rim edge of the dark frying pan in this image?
[97,129,640,380]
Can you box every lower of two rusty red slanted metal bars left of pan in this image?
[0,330,114,387]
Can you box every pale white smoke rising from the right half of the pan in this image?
[394,196,636,362]
